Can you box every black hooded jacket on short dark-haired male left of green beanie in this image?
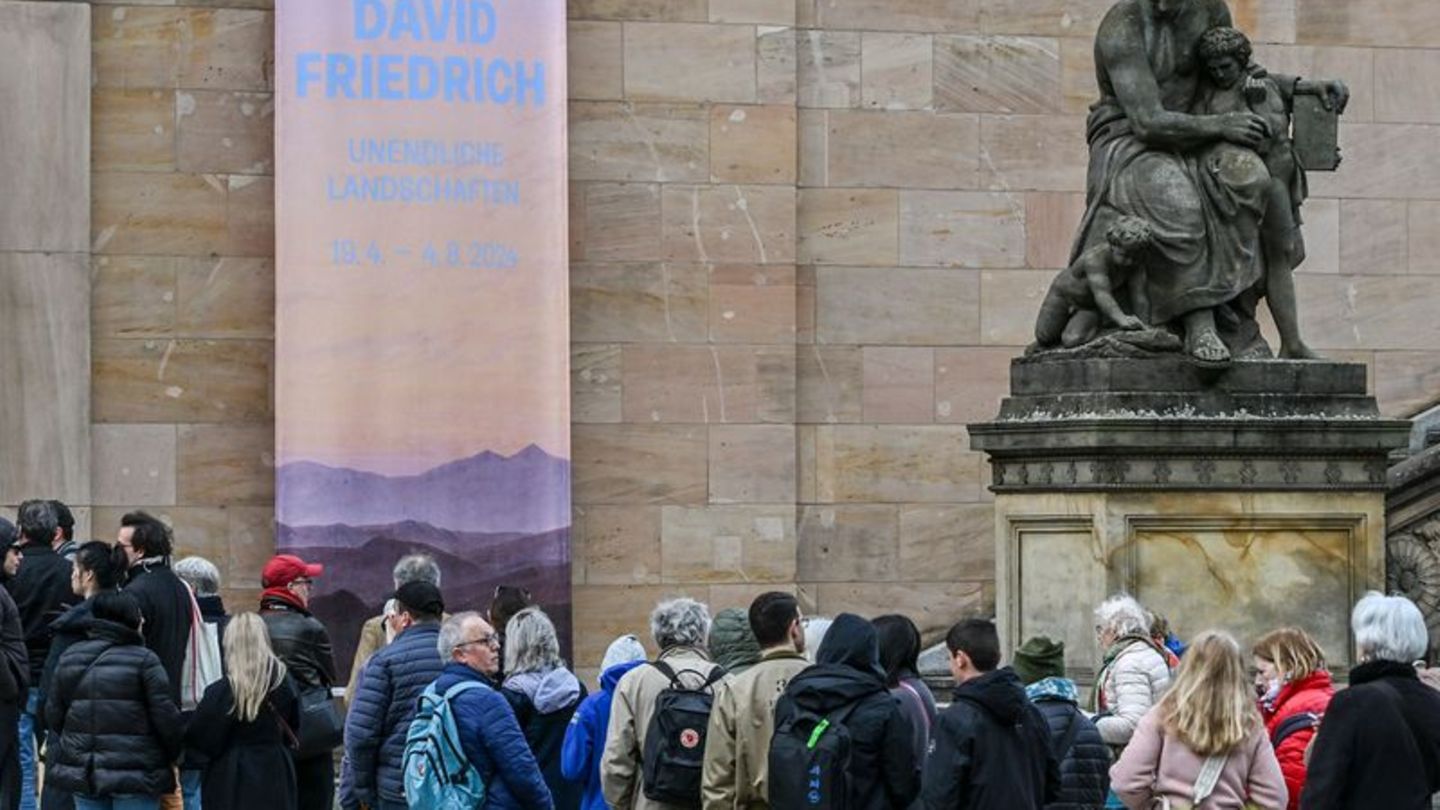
[923,667,1060,810]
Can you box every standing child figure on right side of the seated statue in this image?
[1192,27,1325,359]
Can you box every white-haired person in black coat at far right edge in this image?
[1300,592,1440,810]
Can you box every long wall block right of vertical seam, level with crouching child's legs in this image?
[816,267,981,346]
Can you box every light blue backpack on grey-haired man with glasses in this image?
[402,680,485,810]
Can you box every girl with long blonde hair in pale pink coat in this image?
[1110,631,1287,810]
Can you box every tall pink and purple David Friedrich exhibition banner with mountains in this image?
[275,0,570,672]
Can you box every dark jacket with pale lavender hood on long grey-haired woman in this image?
[503,667,585,810]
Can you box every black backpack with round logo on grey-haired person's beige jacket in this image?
[642,662,726,807]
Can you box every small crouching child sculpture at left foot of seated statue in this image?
[1035,216,1155,349]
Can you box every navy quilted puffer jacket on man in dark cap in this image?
[346,623,444,806]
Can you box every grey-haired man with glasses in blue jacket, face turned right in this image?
[420,613,554,810]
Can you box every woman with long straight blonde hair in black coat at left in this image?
[184,613,300,810]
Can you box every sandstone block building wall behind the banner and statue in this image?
[0,0,1440,664]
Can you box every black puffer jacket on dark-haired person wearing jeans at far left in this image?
[45,620,184,796]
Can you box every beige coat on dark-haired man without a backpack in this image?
[700,650,809,810]
